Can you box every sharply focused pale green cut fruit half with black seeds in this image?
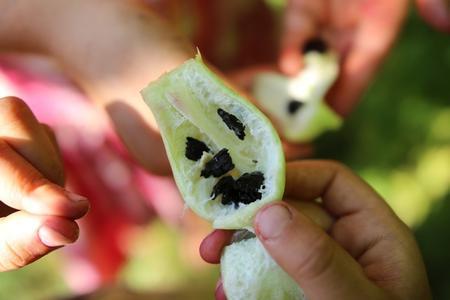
[142,56,285,229]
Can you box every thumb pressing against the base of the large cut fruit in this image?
[254,203,382,300]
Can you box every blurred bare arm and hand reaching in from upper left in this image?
[0,0,193,174]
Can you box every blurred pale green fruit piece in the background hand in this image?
[253,51,342,143]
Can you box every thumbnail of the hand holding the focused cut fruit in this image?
[256,204,292,239]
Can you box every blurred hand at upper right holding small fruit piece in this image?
[279,0,408,115]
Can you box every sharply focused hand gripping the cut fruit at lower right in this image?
[200,161,431,300]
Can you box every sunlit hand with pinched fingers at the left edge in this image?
[0,97,89,272]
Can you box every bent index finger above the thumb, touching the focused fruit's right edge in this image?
[285,160,390,217]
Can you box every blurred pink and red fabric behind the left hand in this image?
[0,55,183,293]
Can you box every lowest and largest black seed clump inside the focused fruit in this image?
[211,172,264,208]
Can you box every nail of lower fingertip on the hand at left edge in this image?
[38,223,78,247]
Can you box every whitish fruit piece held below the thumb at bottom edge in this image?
[220,238,304,300]
